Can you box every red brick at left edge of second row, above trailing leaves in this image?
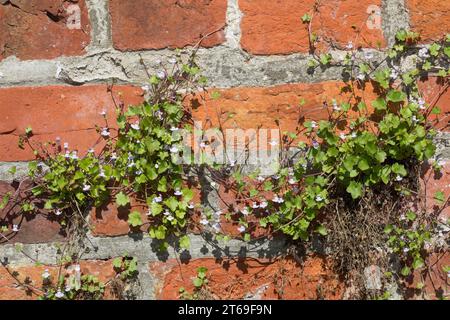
[0,85,143,161]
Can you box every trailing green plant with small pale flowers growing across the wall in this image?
[0,26,450,298]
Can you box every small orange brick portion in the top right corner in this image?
[406,0,450,42]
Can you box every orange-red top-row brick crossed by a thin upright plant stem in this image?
[239,0,385,54]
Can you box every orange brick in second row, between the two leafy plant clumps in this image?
[190,81,375,136]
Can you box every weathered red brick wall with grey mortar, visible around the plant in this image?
[0,0,450,299]
